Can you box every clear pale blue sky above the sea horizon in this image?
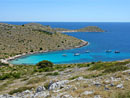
[0,0,130,22]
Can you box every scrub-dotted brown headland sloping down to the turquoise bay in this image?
[0,23,82,58]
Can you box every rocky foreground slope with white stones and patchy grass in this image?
[0,60,130,98]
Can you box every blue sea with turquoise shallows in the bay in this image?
[1,22,130,64]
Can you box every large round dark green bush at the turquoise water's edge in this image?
[36,60,53,71]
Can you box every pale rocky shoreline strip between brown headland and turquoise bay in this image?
[0,40,89,64]
